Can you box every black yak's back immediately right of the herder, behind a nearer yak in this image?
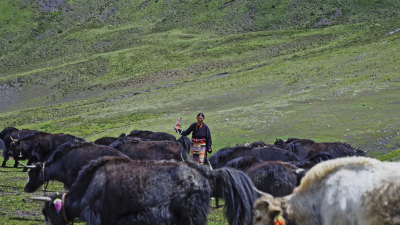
[209,145,299,169]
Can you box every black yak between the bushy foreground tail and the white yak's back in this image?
[226,156,304,197]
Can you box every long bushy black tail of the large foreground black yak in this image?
[188,162,258,225]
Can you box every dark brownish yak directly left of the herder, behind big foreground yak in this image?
[110,137,187,161]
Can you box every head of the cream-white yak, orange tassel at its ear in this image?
[253,193,288,225]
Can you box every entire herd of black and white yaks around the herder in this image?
[0,127,400,225]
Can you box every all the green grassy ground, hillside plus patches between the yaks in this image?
[0,0,400,224]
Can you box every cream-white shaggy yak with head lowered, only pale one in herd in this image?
[253,157,400,225]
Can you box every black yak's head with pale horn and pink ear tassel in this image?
[31,193,68,225]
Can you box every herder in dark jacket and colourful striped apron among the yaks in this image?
[174,113,212,164]
